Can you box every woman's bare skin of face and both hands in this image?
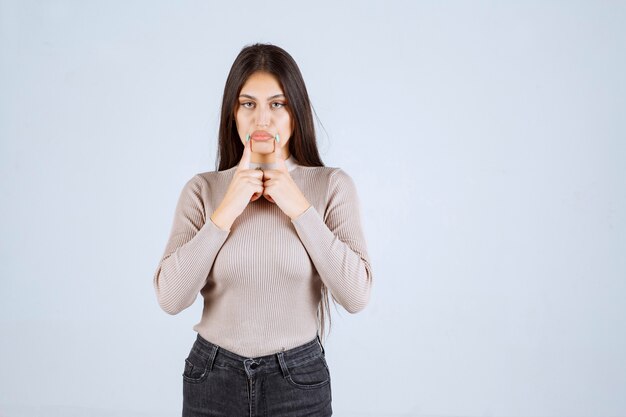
[211,72,311,230]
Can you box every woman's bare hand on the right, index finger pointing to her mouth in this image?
[263,146,311,220]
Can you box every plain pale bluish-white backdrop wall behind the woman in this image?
[0,0,626,417]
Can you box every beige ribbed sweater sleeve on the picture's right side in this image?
[292,168,372,313]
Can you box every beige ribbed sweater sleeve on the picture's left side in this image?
[153,175,230,314]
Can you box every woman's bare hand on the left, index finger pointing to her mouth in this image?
[211,140,263,230]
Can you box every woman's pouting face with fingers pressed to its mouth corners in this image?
[235,72,293,163]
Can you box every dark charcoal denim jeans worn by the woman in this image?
[182,334,332,417]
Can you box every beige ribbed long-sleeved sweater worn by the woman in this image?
[153,156,372,357]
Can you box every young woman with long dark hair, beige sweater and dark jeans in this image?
[154,44,372,417]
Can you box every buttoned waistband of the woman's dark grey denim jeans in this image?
[192,333,325,377]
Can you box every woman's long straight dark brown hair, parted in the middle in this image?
[216,43,331,338]
